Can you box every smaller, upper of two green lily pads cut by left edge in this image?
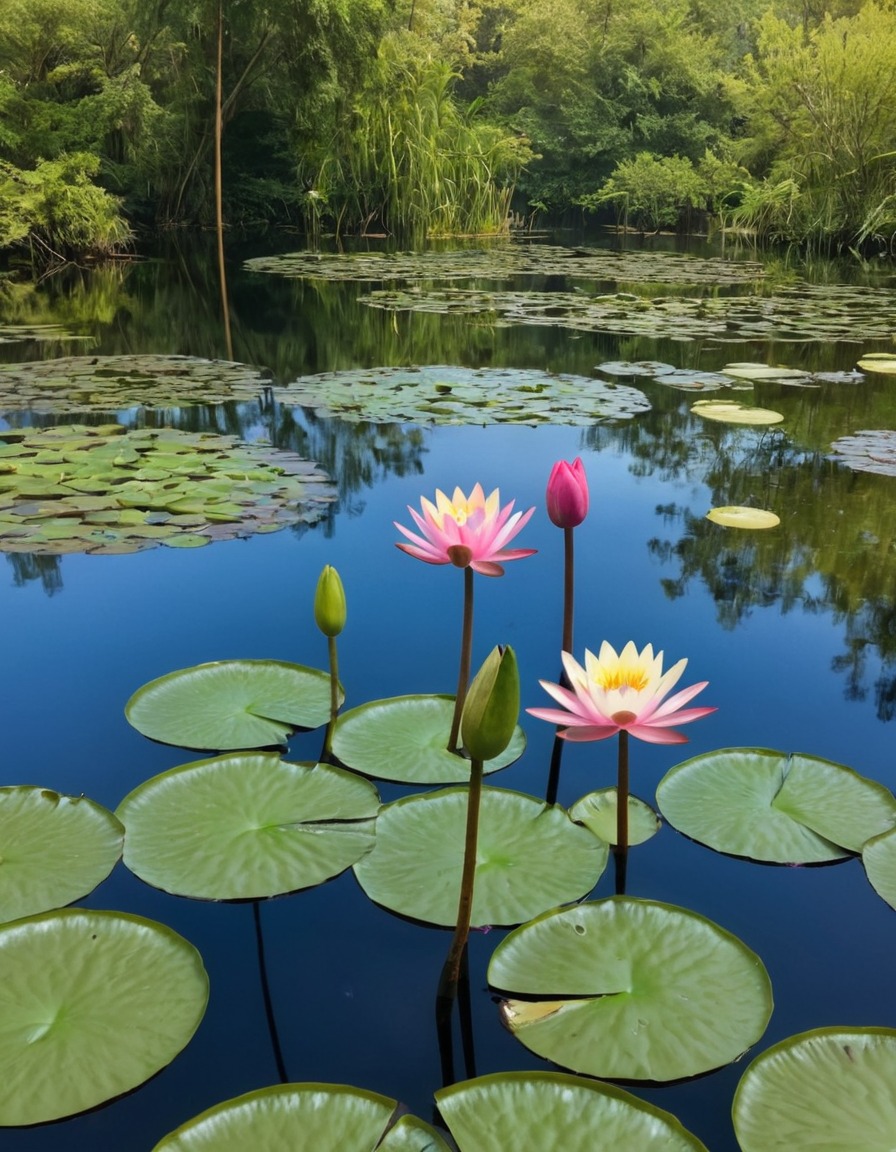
[0,785,124,920]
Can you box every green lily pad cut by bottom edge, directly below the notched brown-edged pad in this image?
[435,1071,706,1152]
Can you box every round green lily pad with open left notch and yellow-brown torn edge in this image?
[488,896,772,1081]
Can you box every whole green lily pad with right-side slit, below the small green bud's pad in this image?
[116,752,379,900]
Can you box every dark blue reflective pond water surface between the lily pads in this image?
[0,229,896,1152]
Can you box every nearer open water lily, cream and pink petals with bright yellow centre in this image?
[526,641,716,744]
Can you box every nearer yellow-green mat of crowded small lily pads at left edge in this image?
[0,424,335,554]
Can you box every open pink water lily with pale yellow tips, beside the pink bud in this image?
[395,484,536,576]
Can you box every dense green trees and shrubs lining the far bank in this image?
[0,0,896,260]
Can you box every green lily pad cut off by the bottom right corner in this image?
[731,1028,896,1152]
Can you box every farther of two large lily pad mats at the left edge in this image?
[0,359,271,415]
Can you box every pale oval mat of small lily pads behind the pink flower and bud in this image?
[275,365,651,425]
